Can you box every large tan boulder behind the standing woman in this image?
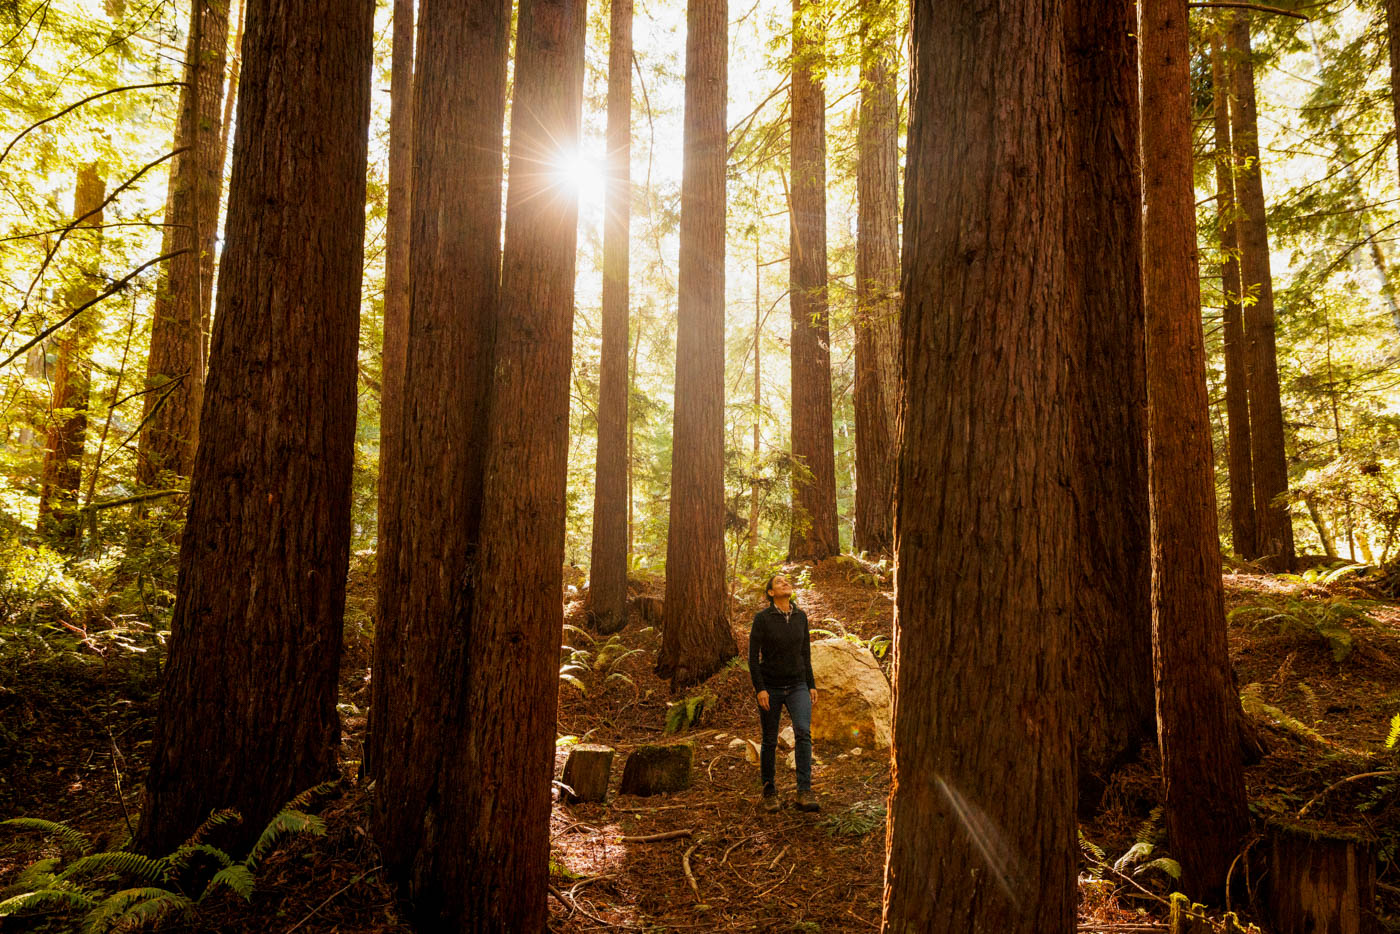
[812,639,893,749]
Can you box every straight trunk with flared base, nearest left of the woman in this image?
[657,0,738,689]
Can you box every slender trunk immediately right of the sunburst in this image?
[588,0,631,634]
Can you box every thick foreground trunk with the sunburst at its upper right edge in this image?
[456,0,588,918]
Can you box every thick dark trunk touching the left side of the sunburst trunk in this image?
[370,0,511,926]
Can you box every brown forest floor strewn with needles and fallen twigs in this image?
[8,562,1400,934]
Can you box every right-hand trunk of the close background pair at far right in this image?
[1226,13,1294,569]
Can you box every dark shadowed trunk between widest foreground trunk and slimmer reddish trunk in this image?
[1065,0,1156,809]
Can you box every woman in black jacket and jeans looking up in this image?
[749,574,822,811]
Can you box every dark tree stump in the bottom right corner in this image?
[1268,822,1379,934]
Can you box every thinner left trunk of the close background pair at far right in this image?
[1211,32,1259,557]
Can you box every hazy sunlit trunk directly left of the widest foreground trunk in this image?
[853,0,899,553]
